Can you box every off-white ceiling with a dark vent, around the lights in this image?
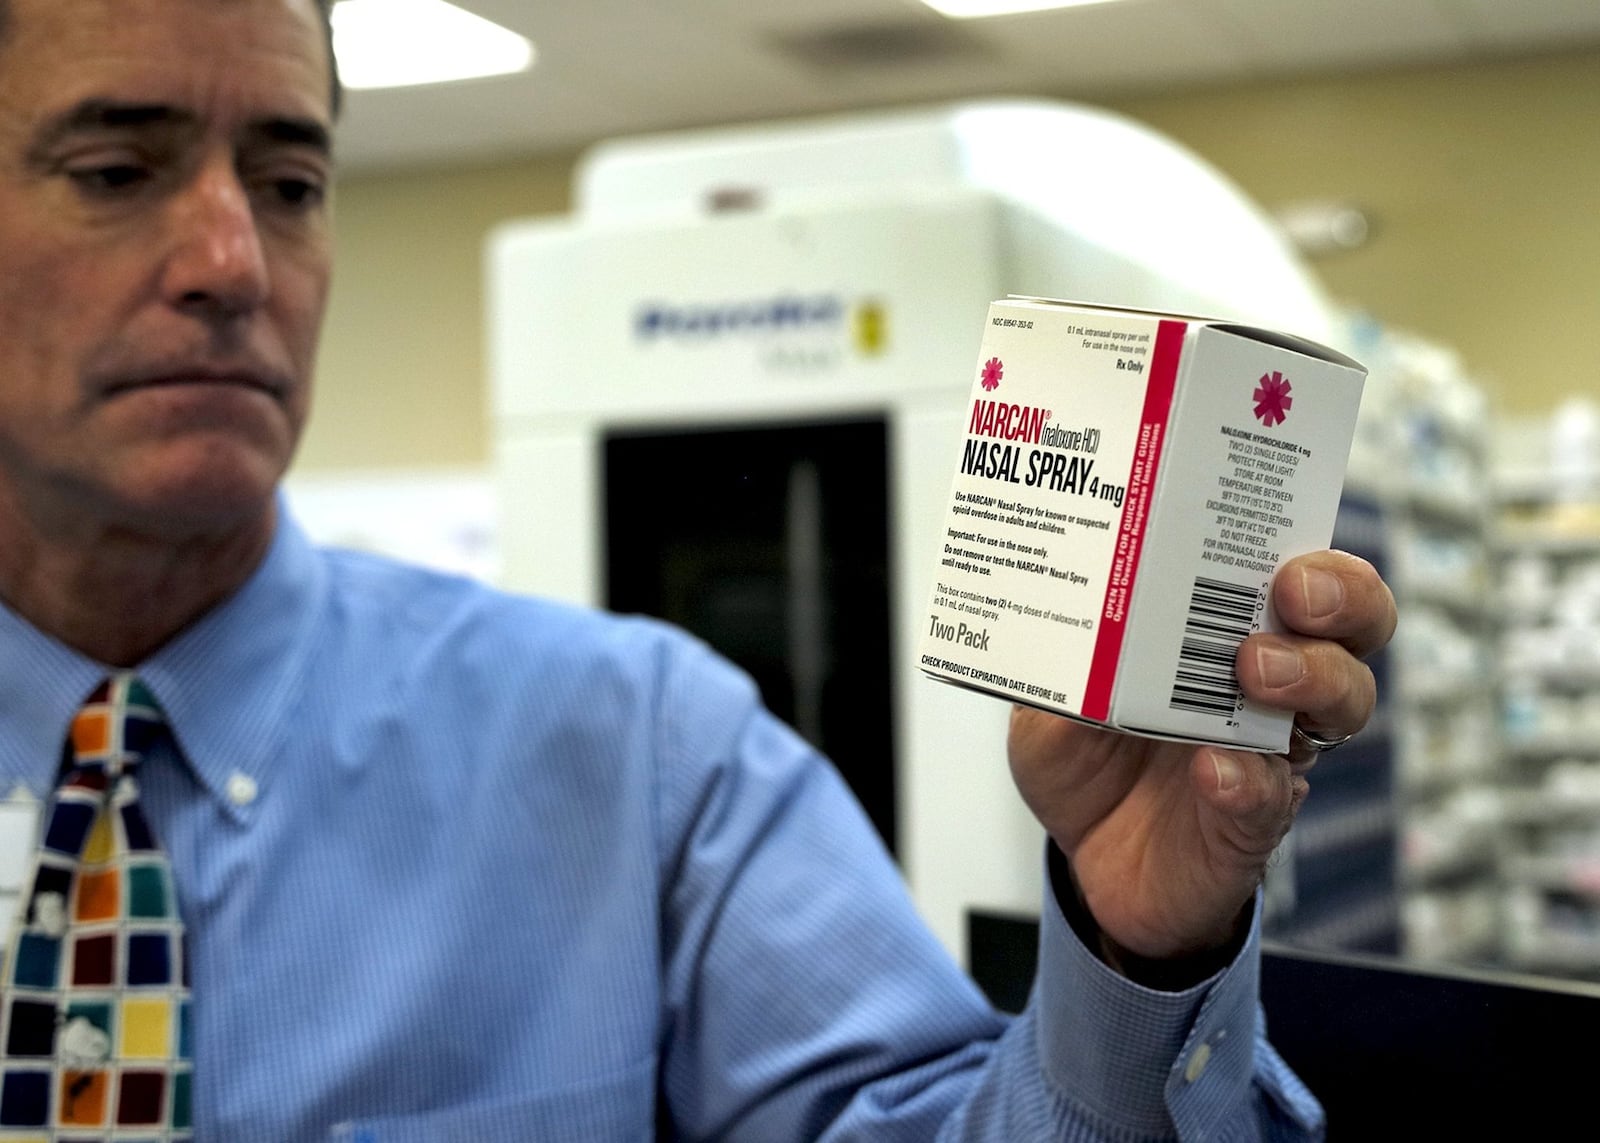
[339,0,1600,173]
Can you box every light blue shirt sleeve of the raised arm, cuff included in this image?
[656,637,1322,1143]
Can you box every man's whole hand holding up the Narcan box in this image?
[1008,552,1395,959]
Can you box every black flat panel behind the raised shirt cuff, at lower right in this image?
[968,912,1600,1141]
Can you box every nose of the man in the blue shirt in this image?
[163,162,270,320]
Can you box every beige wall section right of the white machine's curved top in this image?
[1120,51,1600,413]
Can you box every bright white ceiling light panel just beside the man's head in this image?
[333,0,533,88]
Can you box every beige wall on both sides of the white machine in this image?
[301,51,1600,471]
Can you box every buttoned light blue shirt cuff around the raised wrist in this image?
[1035,851,1261,1138]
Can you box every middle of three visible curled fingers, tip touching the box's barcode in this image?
[1234,632,1378,738]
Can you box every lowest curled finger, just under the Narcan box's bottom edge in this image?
[1192,748,1310,877]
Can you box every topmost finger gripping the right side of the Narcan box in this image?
[1272,551,1395,658]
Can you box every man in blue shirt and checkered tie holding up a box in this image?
[0,0,1394,1143]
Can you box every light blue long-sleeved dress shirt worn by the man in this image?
[0,522,1320,1143]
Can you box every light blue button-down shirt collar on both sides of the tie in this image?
[0,496,326,816]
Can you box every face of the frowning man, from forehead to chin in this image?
[0,0,331,539]
